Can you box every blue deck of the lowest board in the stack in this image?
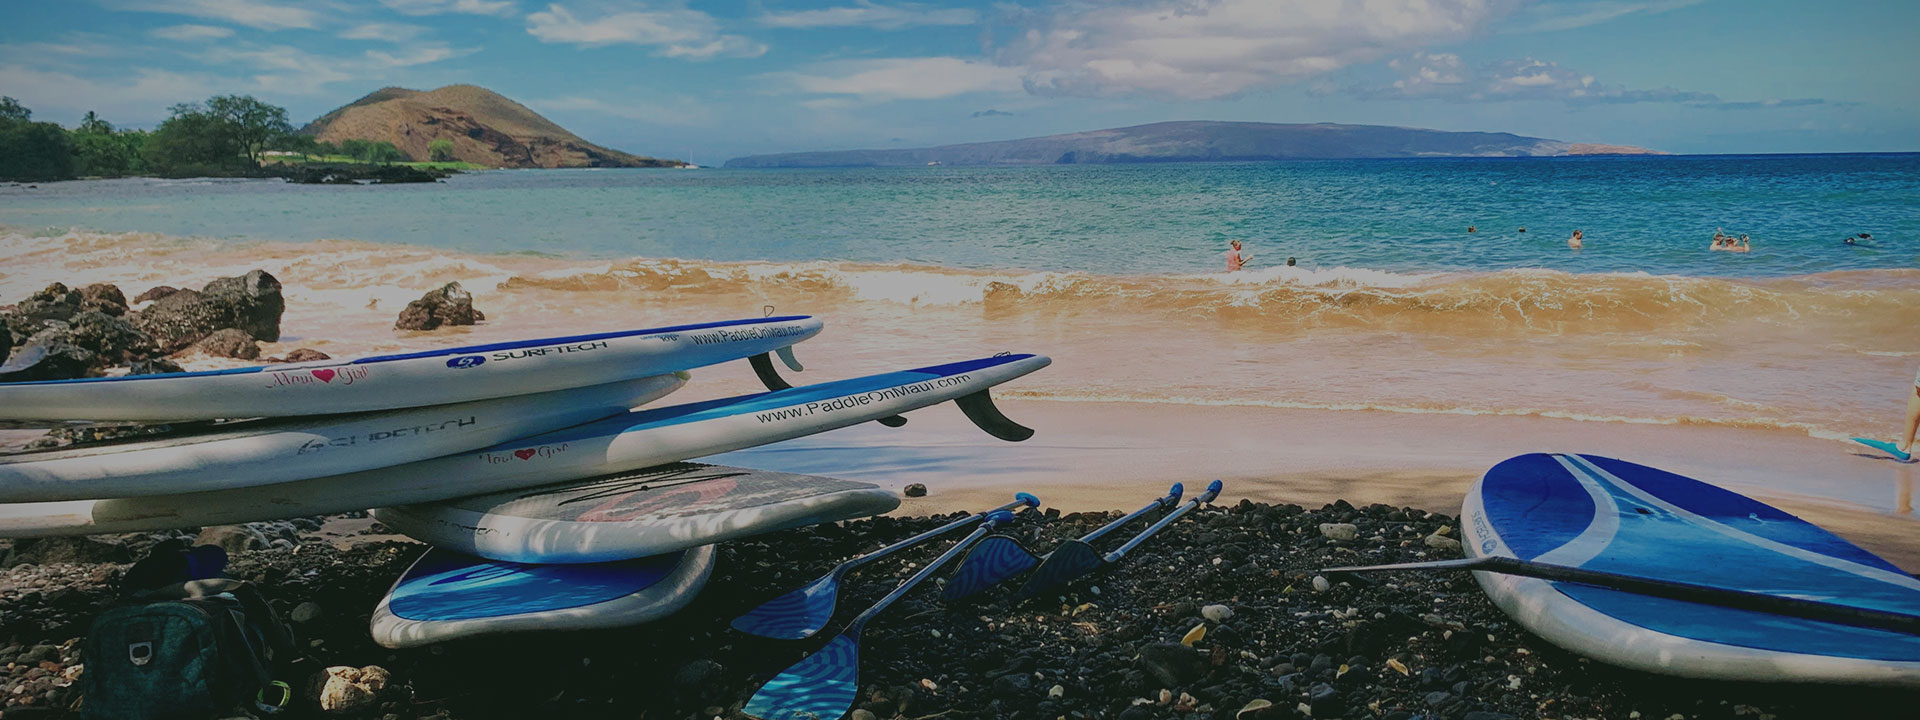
[386,549,685,622]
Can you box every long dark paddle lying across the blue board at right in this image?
[1321,555,1920,636]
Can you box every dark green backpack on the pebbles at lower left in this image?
[81,578,294,720]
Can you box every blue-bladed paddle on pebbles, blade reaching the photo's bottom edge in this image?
[741,511,1014,720]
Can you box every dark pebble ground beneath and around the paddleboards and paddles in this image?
[0,501,1889,720]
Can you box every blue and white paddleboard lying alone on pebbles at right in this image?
[1461,453,1920,685]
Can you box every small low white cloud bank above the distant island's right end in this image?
[1351,52,1826,109]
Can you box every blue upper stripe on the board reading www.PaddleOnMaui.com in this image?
[490,355,1033,449]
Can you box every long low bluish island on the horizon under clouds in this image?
[726,121,1661,167]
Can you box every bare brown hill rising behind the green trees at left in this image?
[301,84,684,167]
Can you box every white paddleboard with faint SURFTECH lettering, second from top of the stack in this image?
[0,376,682,503]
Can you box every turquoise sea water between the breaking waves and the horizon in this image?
[0,154,1920,276]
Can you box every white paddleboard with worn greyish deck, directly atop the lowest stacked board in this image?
[374,463,900,563]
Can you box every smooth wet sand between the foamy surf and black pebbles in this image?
[718,391,1920,572]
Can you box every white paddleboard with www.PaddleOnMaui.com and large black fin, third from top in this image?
[0,355,1052,538]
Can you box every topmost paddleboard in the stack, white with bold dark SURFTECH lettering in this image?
[0,315,820,420]
